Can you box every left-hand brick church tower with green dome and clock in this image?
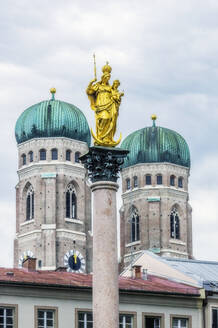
[14,88,91,272]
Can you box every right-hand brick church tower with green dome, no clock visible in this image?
[120,115,192,267]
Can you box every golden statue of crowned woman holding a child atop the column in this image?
[86,63,124,147]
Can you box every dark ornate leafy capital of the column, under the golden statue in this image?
[80,146,129,183]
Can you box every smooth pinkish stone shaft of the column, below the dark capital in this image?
[91,181,119,328]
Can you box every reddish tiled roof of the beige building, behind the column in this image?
[0,268,200,296]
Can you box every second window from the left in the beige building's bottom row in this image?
[35,306,57,328]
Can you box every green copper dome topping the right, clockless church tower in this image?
[121,115,190,168]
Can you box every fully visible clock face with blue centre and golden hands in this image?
[64,250,85,273]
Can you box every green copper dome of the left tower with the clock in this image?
[15,88,91,146]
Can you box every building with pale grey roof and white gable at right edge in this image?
[121,251,218,328]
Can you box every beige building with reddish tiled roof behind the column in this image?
[0,260,204,328]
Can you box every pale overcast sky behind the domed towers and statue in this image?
[0,0,218,266]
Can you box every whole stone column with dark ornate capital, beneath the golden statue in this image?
[80,147,128,328]
